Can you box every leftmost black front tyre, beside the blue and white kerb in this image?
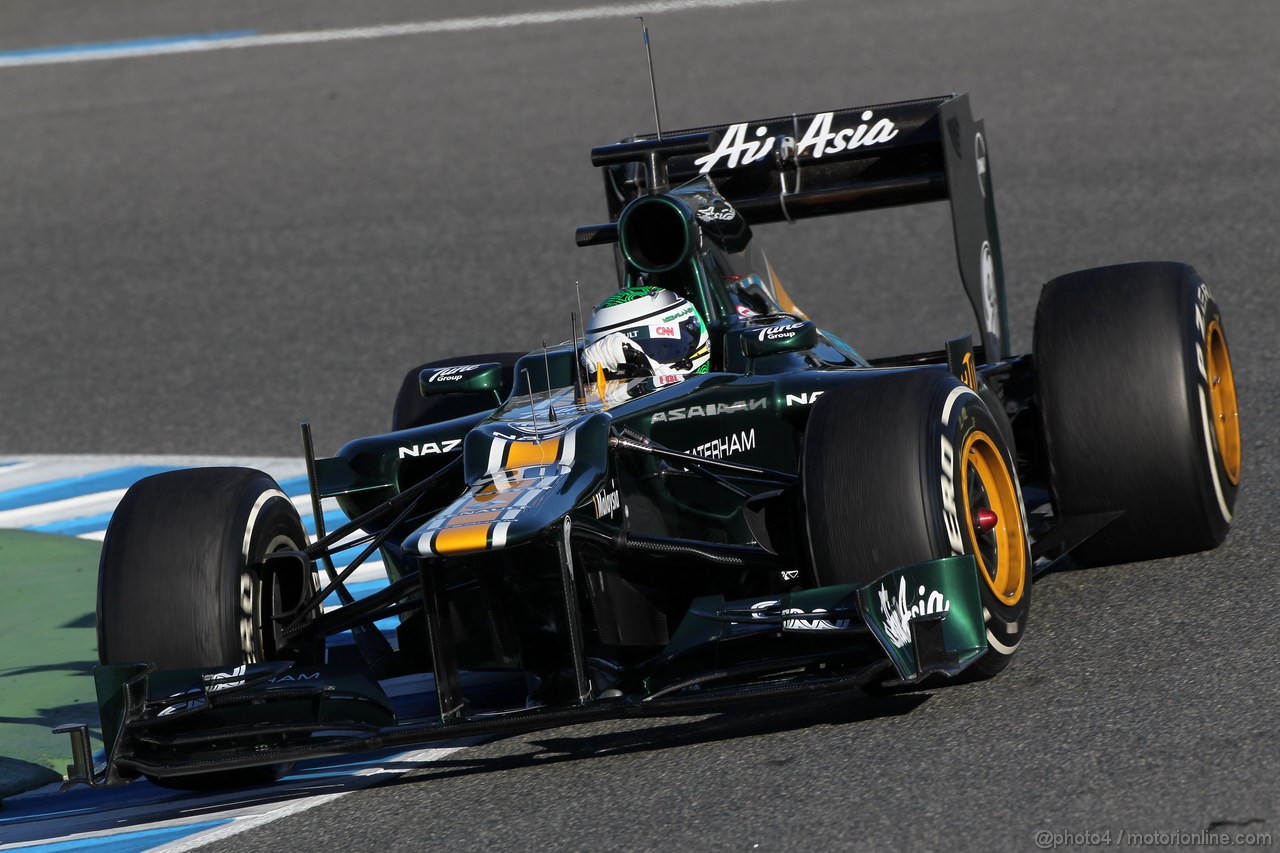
[97,467,323,788]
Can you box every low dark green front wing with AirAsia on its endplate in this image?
[70,556,987,784]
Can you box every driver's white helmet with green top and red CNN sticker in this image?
[585,284,710,379]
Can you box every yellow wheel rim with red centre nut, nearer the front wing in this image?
[960,429,1027,605]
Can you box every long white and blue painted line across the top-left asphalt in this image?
[0,0,800,68]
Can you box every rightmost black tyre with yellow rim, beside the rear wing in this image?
[1034,263,1242,565]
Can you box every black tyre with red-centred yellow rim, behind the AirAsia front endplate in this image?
[801,370,1032,678]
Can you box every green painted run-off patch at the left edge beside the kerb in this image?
[0,530,102,798]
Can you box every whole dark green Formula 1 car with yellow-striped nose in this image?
[73,95,1242,785]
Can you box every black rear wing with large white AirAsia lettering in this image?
[577,95,1009,361]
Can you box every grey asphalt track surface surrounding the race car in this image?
[0,0,1280,850]
